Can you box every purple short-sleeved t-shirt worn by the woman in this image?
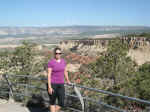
[48,59,66,84]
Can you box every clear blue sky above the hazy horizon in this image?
[0,0,150,26]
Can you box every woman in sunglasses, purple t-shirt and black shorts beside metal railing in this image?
[48,48,70,112]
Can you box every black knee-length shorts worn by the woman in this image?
[48,84,65,107]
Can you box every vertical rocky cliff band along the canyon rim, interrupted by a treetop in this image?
[60,37,150,50]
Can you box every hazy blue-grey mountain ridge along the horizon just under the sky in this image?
[0,25,150,35]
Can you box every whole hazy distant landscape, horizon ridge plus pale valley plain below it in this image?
[0,25,150,45]
